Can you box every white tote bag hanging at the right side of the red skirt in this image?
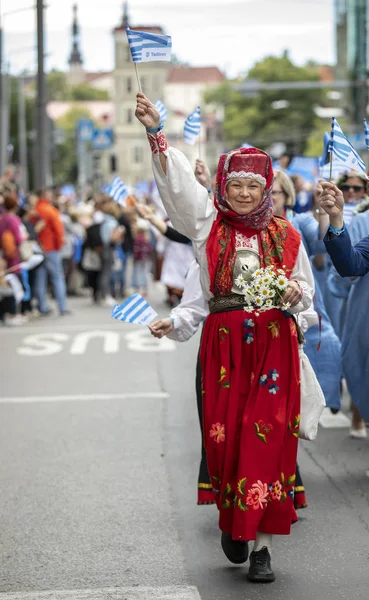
[299,346,326,441]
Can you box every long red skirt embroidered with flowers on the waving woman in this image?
[200,309,300,540]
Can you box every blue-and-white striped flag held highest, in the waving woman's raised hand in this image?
[126,27,172,62]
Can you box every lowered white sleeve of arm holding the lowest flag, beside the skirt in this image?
[167,260,209,342]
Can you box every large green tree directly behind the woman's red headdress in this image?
[205,52,322,153]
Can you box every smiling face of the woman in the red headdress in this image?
[226,177,264,215]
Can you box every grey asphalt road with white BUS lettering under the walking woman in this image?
[0,286,369,600]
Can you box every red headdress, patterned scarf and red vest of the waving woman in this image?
[207,148,301,296]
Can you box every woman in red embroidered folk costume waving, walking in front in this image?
[136,94,314,582]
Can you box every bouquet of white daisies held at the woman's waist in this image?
[235,267,289,311]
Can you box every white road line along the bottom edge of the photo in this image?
[1,586,201,600]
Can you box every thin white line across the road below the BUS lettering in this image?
[0,392,169,406]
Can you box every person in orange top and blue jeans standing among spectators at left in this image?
[35,190,69,315]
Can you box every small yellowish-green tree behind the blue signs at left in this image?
[52,107,91,185]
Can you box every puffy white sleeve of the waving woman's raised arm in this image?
[153,147,215,243]
